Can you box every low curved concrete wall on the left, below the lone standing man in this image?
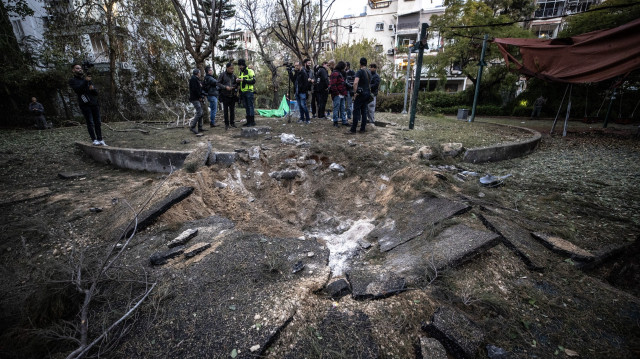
[76,142,190,173]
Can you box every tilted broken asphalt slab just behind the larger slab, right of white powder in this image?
[371,197,471,252]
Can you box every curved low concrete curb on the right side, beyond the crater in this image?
[462,124,542,163]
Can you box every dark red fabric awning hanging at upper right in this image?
[493,19,640,83]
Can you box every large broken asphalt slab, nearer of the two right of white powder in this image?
[383,224,500,285]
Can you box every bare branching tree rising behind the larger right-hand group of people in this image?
[272,0,335,63]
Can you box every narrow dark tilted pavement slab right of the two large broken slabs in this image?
[478,214,547,271]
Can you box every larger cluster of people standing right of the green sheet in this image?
[288,57,380,133]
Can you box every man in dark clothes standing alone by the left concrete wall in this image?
[69,64,107,146]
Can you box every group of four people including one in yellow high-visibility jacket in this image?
[189,59,256,134]
